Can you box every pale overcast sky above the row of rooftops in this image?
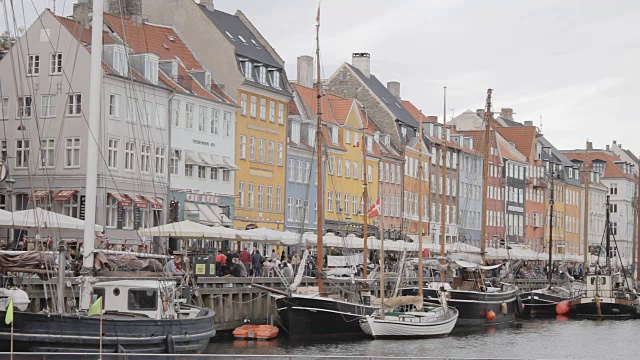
[5,0,640,154]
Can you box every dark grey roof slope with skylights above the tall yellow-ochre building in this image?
[199,5,281,68]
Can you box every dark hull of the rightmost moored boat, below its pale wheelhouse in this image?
[570,297,640,320]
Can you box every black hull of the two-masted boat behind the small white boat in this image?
[402,287,519,327]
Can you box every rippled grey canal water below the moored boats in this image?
[207,318,640,359]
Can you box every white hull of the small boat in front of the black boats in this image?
[360,308,458,339]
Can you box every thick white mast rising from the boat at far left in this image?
[81,0,104,309]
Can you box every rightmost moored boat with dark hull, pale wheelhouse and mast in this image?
[569,195,640,319]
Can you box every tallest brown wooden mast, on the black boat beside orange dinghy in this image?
[316,6,324,294]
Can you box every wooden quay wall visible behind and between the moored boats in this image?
[16,277,556,331]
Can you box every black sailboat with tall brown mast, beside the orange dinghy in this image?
[272,6,377,337]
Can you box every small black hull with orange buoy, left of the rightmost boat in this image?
[518,289,575,318]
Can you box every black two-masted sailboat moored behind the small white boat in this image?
[402,88,518,326]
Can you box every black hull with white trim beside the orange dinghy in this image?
[276,295,378,337]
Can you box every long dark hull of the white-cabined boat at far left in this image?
[0,309,216,354]
